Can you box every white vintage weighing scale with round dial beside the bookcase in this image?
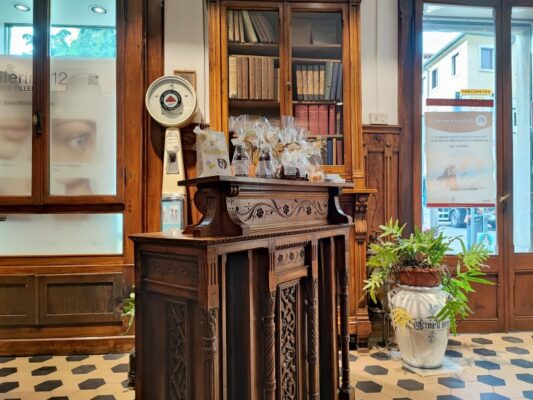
[145,76,196,232]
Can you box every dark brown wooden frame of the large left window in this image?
[0,0,126,209]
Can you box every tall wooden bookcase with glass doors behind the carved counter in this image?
[209,0,371,342]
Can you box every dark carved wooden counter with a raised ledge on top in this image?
[132,177,354,400]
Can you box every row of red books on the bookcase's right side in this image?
[294,104,342,136]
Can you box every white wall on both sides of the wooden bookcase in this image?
[165,0,398,124]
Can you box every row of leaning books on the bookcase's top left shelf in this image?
[228,10,278,43]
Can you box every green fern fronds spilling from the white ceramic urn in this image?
[363,219,494,335]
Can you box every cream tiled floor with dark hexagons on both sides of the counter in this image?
[0,332,533,400]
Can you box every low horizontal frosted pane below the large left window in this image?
[0,214,123,256]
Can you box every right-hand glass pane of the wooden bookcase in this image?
[291,12,344,165]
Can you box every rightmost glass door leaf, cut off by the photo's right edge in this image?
[510,7,533,330]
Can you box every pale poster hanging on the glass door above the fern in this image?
[425,111,496,207]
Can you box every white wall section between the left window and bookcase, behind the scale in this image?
[165,0,209,122]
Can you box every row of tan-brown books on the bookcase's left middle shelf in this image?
[228,55,279,101]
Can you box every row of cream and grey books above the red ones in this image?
[296,61,342,100]
